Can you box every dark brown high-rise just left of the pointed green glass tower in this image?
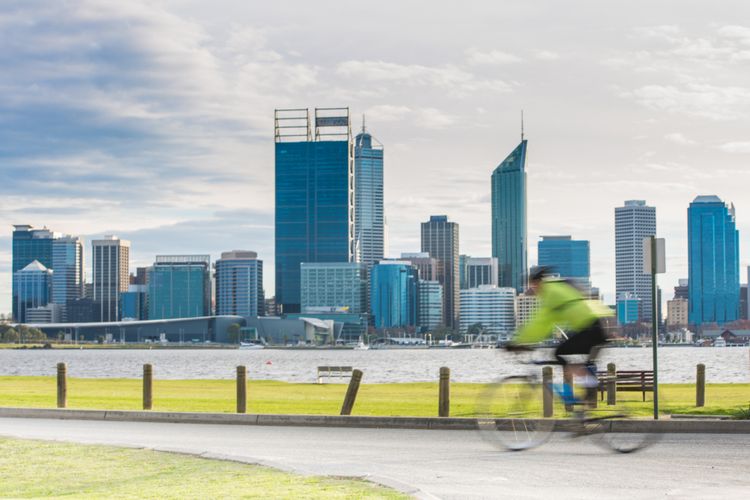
[422,215,461,328]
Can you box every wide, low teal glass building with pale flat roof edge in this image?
[146,255,211,319]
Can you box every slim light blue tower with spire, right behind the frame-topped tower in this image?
[354,119,385,269]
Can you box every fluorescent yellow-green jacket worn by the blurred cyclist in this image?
[513,280,613,344]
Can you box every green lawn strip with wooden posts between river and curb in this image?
[0,377,750,417]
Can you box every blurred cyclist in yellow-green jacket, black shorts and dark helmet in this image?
[507,266,612,399]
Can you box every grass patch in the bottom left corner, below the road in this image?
[0,438,408,499]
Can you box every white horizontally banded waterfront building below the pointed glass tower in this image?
[460,285,516,336]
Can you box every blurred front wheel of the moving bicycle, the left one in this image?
[476,376,555,451]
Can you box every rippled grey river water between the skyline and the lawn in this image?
[0,347,750,383]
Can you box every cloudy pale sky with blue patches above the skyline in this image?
[0,0,750,312]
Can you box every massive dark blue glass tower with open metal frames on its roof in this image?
[275,108,355,313]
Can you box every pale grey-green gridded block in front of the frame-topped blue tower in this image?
[301,262,367,314]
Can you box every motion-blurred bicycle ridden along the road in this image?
[476,350,660,453]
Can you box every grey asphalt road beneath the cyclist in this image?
[0,418,750,500]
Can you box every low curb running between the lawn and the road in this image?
[0,408,750,434]
